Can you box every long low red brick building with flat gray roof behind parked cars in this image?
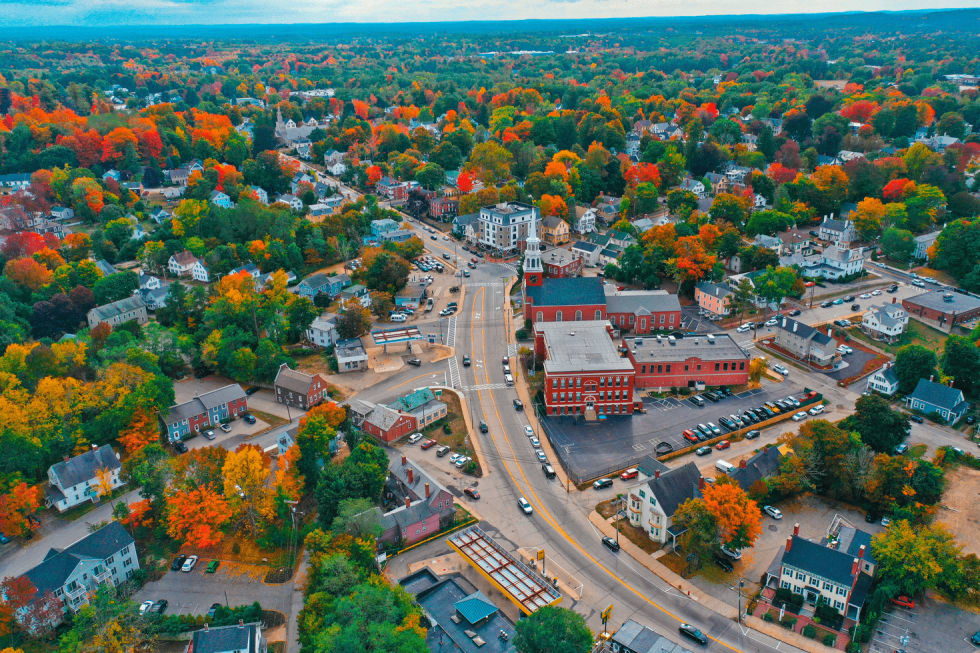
[623,334,749,389]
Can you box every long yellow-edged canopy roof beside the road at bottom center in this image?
[447,526,561,614]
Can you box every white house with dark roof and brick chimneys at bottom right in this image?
[766,524,874,621]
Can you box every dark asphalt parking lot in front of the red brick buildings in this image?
[542,382,802,481]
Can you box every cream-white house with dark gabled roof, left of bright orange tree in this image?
[626,463,704,546]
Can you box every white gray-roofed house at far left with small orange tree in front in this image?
[45,444,124,512]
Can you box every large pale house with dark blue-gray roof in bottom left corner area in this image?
[24,521,140,625]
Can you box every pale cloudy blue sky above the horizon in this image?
[0,0,978,26]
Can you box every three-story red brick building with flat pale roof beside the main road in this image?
[534,320,635,419]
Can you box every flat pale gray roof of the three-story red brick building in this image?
[534,320,633,373]
